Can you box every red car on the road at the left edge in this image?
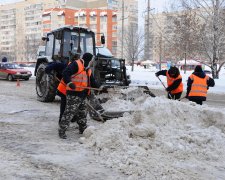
[0,62,32,81]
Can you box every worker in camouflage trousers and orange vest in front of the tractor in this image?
[58,53,100,139]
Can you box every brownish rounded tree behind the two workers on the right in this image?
[168,10,201,73]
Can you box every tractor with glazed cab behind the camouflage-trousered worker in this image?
[35,26,130,102]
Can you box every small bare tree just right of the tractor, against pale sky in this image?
[123,23,144,71]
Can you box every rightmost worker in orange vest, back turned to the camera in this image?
[186,65,215,105]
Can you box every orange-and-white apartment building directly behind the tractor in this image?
[42,8,117,55]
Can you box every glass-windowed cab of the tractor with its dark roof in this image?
[42,26,95,61]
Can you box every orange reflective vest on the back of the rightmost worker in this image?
[188,74,209,97]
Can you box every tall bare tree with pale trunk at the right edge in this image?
[180,0,225,78]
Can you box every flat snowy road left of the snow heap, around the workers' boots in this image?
[0,79,126,180]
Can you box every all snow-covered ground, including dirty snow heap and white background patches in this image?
[0,64,225,180]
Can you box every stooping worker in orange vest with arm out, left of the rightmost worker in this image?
[155,66,183,99]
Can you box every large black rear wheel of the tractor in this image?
[36,64,58,102]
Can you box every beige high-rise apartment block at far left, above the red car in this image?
[0,0,59,61]
